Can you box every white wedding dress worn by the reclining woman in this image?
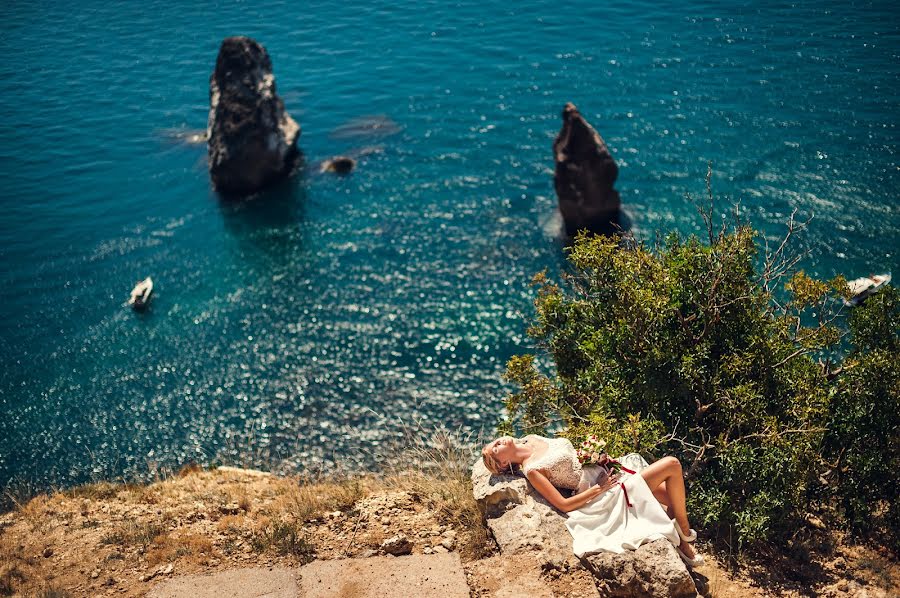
[522,436,681,557]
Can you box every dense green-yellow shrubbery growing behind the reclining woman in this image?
[500,207,900,543]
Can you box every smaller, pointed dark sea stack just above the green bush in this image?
[553,103,621,237]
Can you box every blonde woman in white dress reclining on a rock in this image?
[481,435,703,567]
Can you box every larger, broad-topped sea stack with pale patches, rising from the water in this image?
[207,36,300,195]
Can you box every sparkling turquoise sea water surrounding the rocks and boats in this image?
[0,0,900,486]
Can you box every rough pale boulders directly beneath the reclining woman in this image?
[472,459,698,598]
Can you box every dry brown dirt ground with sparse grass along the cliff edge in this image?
[0,468,900,598]
